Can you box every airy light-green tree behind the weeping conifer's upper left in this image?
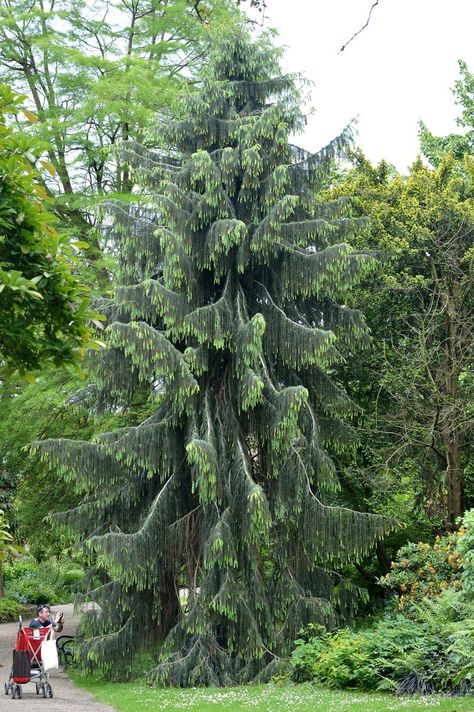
[0,0,241,240]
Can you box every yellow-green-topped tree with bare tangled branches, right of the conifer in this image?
[336,156,474,528]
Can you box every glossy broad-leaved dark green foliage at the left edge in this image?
[0,85,95,373]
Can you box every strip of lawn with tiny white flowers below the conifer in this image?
[71,672,474,712]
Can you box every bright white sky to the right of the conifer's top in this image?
[254,0,474,172]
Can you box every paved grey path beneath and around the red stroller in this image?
[0,605,114,712]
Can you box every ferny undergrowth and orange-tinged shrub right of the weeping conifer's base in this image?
[292,510,474,694]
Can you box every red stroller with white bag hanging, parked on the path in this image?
[5,618,53,699]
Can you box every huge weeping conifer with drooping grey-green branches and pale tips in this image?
[36,33,387,685]
